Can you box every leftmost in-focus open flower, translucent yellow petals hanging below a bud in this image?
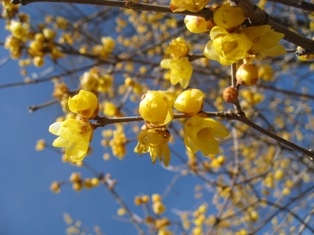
[49,119,93,162]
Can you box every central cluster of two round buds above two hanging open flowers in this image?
[139,89,228,166]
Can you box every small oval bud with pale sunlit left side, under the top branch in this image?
[184,15,214,33]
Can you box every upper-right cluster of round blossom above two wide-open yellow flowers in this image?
[204,3,285,65]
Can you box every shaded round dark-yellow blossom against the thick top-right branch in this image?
[214,3,245,29]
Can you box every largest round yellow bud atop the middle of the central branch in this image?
[139,91,174,126]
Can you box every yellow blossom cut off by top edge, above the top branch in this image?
[170,0,209,12]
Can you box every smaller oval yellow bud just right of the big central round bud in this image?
[174,89,205,116]
